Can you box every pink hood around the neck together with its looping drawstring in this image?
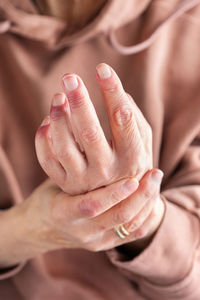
[0,0,200,55]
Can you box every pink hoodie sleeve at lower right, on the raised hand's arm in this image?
[106,137,200,300]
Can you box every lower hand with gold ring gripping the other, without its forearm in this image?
[30,169,162,252]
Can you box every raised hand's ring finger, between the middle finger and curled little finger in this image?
[50,93,86,174]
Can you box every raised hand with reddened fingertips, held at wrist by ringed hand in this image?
[35,64,152,195]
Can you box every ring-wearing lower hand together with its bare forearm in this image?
[0,165,161,267]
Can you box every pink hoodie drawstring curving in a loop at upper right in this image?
[108,0,200,55]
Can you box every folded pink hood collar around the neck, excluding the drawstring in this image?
[0,0,150,49]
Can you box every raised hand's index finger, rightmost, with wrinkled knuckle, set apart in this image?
[96,64,141,153]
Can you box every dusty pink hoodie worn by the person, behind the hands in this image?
[0,0,200,300]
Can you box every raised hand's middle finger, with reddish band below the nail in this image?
[63,74,112,166]
